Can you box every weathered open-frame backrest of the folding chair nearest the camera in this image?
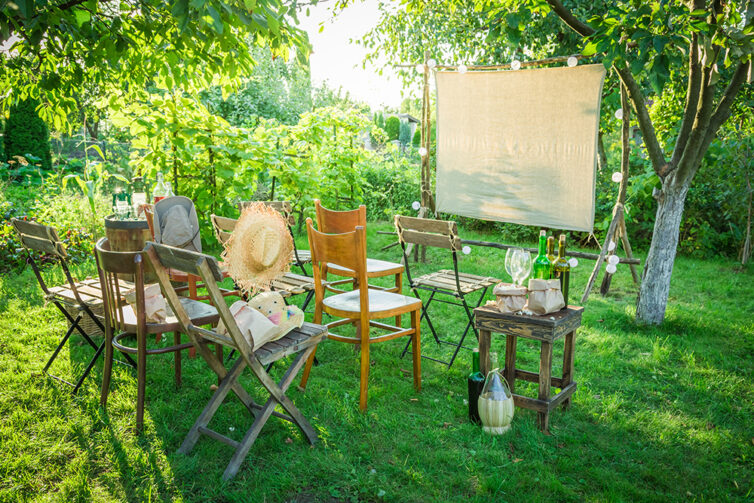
[144,241,254,360]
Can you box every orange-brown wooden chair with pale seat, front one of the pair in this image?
[301,218,421,410]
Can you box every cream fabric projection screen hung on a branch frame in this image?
[435,65,605,232]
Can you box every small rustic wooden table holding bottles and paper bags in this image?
[474,306,584,432]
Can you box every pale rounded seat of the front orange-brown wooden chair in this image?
[322,288,421,319]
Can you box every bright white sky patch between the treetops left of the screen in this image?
[299,0,403,109]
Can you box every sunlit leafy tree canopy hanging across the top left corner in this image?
[0,0,316,129]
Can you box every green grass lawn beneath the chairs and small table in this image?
[0,224,754,502]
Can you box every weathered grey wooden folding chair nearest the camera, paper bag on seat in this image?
[145,242,327,480]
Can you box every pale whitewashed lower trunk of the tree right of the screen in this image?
[636,179,688,325]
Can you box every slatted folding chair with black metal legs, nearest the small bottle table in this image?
[395,215,500,368]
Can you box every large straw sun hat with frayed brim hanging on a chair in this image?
[222,202,293,294]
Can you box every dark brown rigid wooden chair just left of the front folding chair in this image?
[95,238,219,431]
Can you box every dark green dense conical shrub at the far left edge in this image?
[2,99,52,171]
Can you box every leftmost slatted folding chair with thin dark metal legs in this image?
[11,218,136,394]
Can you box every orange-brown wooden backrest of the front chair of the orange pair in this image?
[306,218,369,307]
